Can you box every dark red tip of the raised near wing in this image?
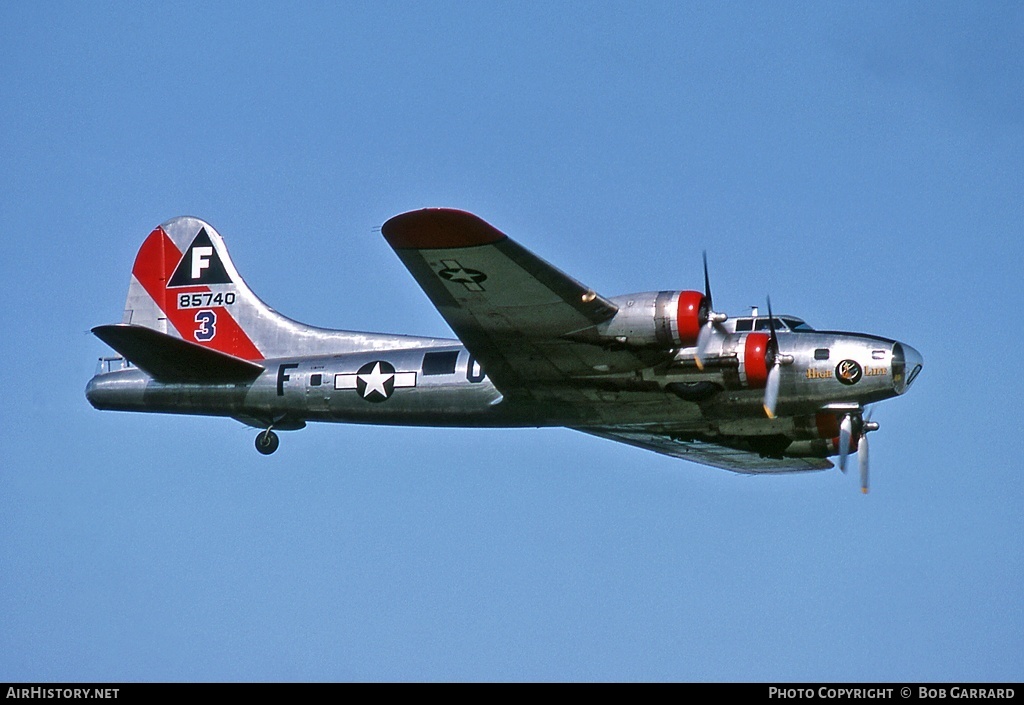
[381,208,506,250]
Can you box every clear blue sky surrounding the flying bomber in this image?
[0,2,1024,681]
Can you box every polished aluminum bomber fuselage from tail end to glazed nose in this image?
[86,321,920,438]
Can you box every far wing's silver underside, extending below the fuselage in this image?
[577,428,834,474]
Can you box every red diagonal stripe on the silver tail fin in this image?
[132,227,263,360]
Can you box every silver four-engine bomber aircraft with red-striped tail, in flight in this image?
[86,208,923,492]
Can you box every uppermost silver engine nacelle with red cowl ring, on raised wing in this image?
[598,291,709,349]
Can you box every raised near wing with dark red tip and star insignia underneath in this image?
[381,208,651,403]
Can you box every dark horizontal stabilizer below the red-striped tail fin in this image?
[92,324,264,384]
